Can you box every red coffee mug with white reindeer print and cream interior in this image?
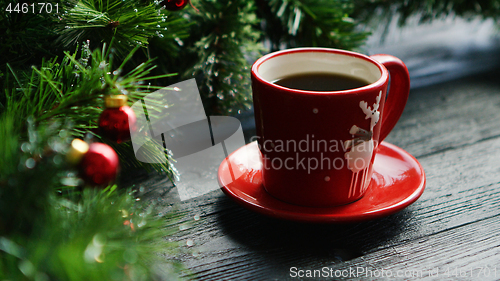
[252,48,410,207]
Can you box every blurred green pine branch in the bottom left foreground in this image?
[0,186,184,281]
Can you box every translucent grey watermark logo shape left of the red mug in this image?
[131,79,245,201]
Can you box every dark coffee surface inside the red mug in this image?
[273,72,369,92]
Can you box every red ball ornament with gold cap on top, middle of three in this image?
[99,95,137,143]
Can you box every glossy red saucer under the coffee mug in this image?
[218,142,425,222]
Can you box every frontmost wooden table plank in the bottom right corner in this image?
[332,215,500,280]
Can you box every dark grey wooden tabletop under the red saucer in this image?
[142,66,500,280]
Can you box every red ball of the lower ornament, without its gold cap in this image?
[78,143,119,186]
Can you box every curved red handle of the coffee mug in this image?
[370,54,410,143]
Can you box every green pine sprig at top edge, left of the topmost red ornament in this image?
[58,0,169,55]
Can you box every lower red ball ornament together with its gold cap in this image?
[67,139,119,186]
